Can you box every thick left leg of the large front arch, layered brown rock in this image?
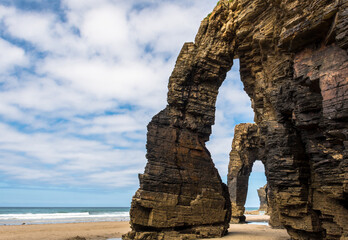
[123,4,233,239]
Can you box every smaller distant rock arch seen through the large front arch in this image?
[227,123,282,228]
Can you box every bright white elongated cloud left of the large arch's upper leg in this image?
[40,58,167,107]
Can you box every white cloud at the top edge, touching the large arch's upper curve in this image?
[131,2,203,54]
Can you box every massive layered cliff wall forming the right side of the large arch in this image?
[228,1,348,236]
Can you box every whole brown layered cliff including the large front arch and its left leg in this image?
[124,0,348,239]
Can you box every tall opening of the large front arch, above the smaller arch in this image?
[206,59,254,184]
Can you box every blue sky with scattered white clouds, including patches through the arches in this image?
[0,0,266,207]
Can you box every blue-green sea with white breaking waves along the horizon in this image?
[0,207,266,225]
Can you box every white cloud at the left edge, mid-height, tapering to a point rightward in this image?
[0,76,117,124]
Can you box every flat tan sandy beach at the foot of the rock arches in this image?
[0,215,290,240]
